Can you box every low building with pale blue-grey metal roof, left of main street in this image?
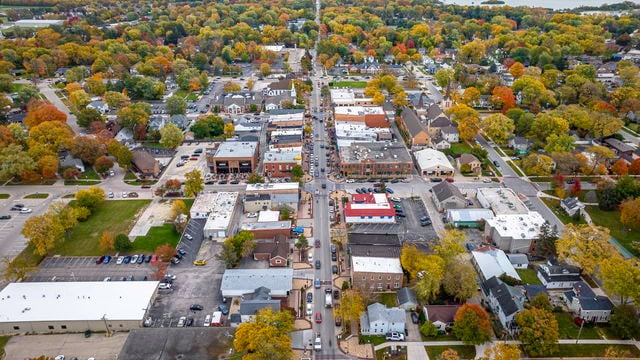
[220,268,293,298]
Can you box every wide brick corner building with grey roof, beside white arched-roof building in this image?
[339,142,413,178]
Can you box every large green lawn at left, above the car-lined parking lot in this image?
[49,200,151,256]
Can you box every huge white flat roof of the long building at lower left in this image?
[0,281,158,322]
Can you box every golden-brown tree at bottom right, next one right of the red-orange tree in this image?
[516,308,560,356]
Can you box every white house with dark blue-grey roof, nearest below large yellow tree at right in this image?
[563,281,613,323]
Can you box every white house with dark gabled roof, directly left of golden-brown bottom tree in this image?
[480,276,526,332]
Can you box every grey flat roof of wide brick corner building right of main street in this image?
[340,142,411,163]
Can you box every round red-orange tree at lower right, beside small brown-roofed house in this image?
[453,303,491,345]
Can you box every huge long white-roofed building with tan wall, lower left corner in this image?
[0,281,158,334]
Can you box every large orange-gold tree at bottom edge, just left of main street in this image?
[233,308,294,360]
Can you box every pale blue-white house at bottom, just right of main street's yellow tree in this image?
[360,303,406,335]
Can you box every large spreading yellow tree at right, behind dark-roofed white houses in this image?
[556,224,620,274]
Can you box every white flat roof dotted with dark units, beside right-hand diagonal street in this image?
[487,211,545,240]
